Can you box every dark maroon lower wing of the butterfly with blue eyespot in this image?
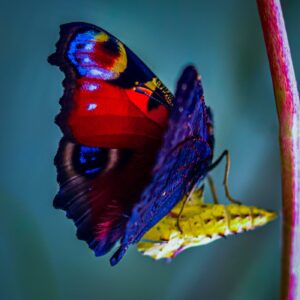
[54,138,161,255]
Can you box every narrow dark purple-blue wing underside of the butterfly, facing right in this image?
[110,66,214,265]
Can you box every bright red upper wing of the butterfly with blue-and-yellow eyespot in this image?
[49,23,172,148]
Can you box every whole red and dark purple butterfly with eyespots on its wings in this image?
[48,23,214,265]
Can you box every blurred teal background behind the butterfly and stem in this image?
[0,0,300,300]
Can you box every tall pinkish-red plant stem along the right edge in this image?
[257,0,300,300]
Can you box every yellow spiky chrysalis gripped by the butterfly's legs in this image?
[137,191,276,259]
